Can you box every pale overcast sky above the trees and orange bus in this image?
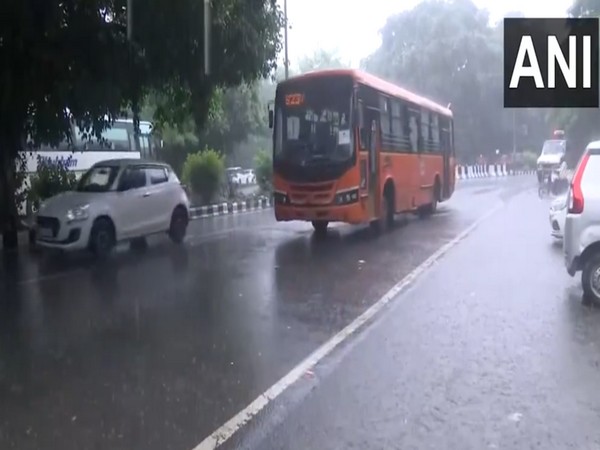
[278,0,572,66]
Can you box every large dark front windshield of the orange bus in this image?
[274,77,353,166]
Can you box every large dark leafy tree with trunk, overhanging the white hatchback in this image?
[0,0,282,248]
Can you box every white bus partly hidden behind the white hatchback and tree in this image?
[19,119,162,215]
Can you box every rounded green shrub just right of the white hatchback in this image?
[182,148,225,203]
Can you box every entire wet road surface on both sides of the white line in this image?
[0,176,600,450]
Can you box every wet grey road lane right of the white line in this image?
[236,185,600,450]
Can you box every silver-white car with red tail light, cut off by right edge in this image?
[563,141,600,302]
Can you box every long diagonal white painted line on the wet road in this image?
[193,202,504,450]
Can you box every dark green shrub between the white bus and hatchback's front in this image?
[27,155,77,209]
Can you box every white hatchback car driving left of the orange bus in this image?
[35,159,190,256]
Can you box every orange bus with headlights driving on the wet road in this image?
[269,69,456,236]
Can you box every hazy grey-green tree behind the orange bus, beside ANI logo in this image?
[363,0,547,162]
